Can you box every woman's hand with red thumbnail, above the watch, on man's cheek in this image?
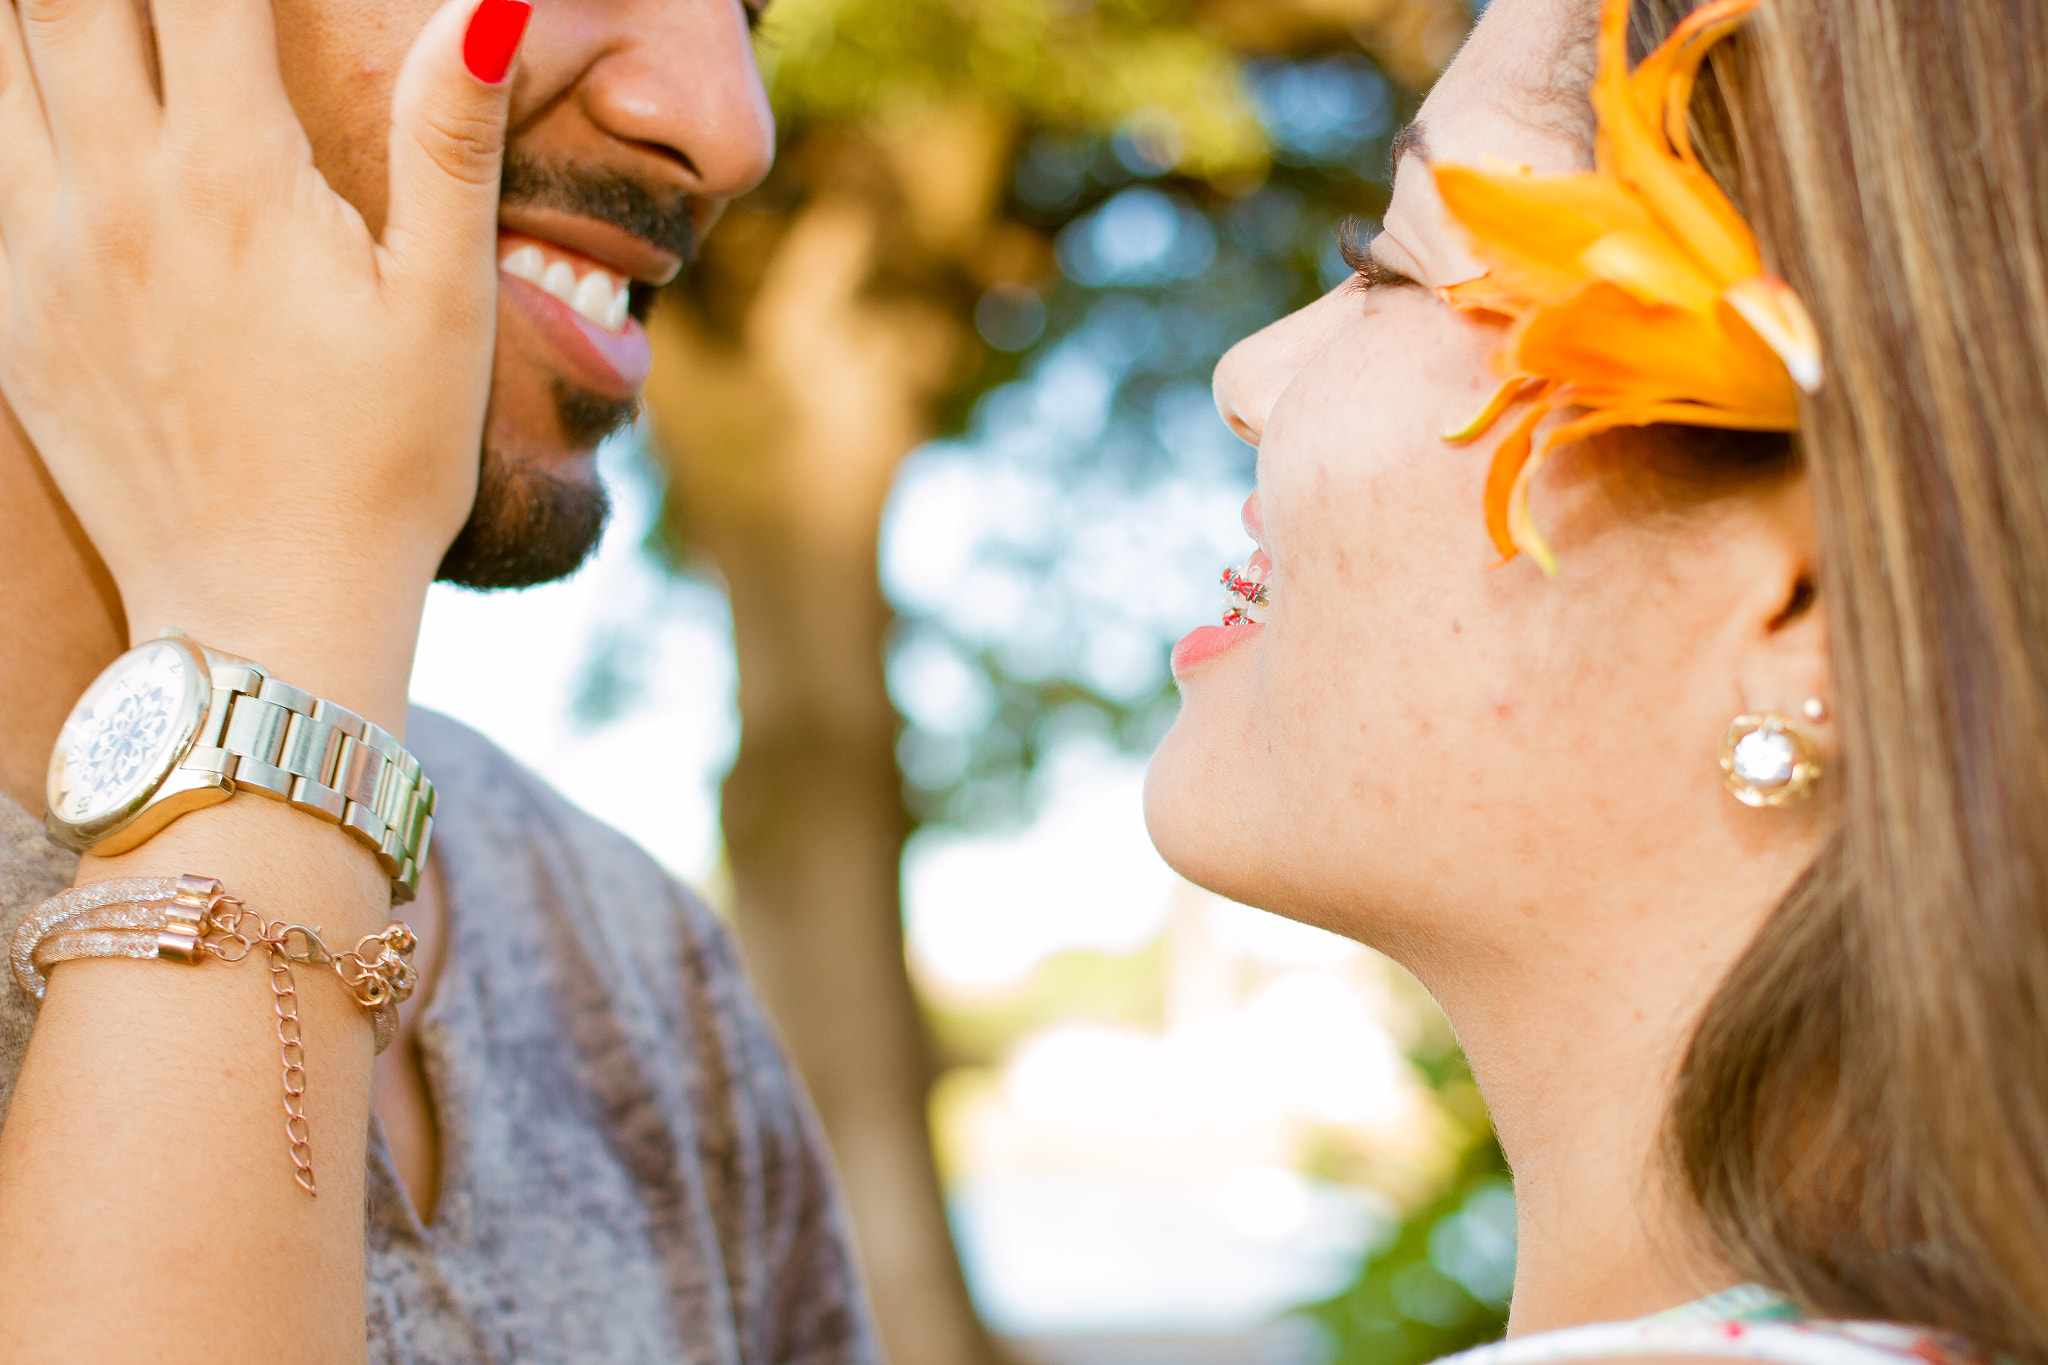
[0,0,528,729]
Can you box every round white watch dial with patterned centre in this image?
[49,641,195,825]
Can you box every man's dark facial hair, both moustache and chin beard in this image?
[434,147,696,589]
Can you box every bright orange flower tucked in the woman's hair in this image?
[1432,0,1821,573]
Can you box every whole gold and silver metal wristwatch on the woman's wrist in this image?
[43,630,434,902]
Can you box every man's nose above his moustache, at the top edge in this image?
[561,0,774,201]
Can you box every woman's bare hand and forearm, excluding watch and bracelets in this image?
[0,0,526,1365]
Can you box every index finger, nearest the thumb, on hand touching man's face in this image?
[152,0,299,145]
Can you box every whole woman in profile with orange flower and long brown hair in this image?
[1147,0,2048,1361]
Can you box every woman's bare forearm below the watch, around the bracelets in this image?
[0,630,412,1363]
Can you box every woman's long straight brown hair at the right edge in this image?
[1636,0,2048,1363]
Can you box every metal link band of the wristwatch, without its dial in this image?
[178,651,434,905]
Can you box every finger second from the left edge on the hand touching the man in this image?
[18,0,162,166]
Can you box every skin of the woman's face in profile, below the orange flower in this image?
[1147,0,1825,966]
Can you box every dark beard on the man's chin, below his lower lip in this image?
[434,379,637,589]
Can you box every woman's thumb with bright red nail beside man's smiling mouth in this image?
[383,0,532,298]
